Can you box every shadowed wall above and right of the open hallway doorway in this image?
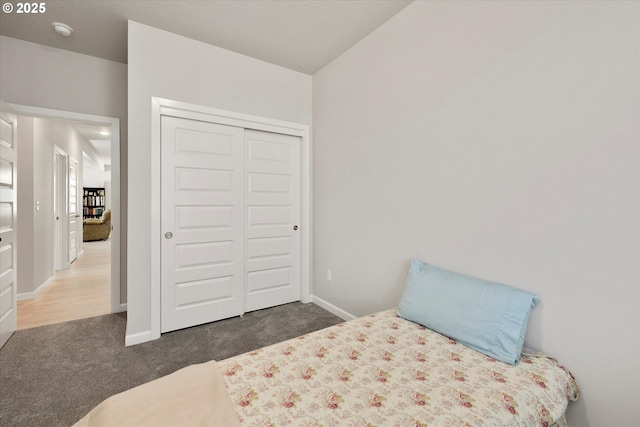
[0,36,127,303]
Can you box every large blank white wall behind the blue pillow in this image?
[313,1,640,426]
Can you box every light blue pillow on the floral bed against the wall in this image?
[398,259,536,365]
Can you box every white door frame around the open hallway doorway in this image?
[9,104,122,313]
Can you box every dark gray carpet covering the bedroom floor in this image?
[0,303,342,427]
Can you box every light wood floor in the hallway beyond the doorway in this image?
[18,240,111,329]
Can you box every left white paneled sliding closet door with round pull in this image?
[160,116,244,332]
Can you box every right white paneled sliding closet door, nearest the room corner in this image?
[245,130,300,311]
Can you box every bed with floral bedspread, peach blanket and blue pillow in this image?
[77,260,579,427]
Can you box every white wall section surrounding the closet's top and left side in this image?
[127,21,311,342]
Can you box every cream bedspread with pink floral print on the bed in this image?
[218,310,578,427]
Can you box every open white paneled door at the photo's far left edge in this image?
[0,100,18,347]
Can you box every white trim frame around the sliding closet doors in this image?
[150,97,313,339]
